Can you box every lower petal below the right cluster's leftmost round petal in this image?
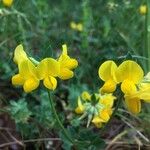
[100,80,116,93]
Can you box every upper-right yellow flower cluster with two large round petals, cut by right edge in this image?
[98,60,150,114]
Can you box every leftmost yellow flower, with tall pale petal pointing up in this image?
[12,45,39,92]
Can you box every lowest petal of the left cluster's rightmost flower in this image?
[59,68,74,80]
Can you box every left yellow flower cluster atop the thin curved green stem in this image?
[12,45,78,92]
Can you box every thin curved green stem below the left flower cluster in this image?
[47,90,74,144]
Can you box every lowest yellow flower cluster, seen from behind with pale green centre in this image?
[75,91,116,128]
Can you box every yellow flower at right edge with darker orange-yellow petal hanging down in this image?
[125,84,150,114]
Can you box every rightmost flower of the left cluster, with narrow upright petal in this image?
[58,44,78,80]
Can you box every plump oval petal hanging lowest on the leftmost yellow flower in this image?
[23,78,39,93]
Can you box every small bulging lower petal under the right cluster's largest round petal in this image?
[121,80,137,94]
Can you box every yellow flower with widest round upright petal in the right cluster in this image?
[116,60,144,94]
